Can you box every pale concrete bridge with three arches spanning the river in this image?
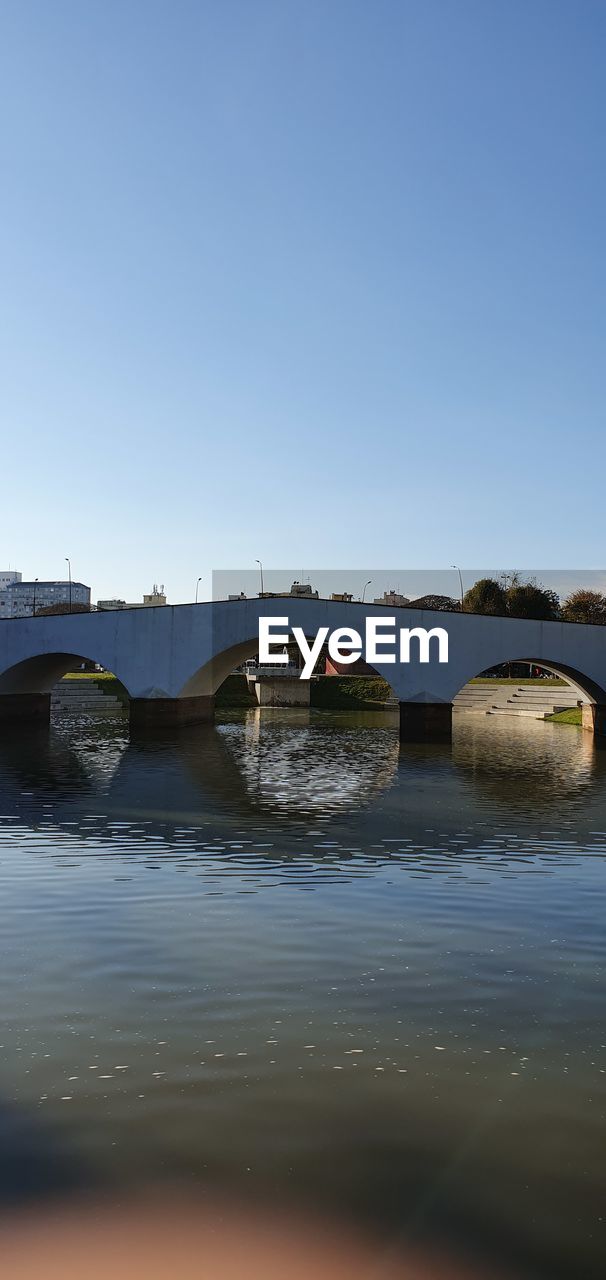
[0,596,606,741]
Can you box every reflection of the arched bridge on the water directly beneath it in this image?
[0,710,606,867]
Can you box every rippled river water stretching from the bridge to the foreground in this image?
[0,712,606,1277]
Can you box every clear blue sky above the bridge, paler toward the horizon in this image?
[0,0,606,600]
